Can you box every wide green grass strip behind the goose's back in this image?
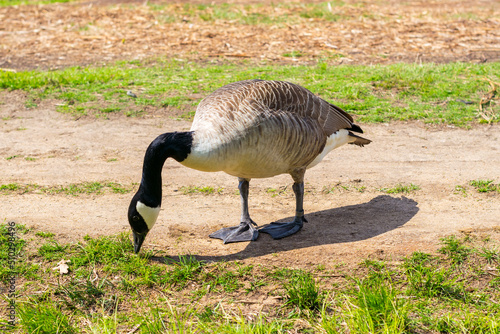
[0,60,500,126]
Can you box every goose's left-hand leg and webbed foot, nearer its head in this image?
[210,178,259,244]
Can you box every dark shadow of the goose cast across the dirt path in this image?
[153,195,419,261]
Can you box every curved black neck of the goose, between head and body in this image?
[138,132,193,207]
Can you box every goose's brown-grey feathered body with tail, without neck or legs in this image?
[181,80,370,179]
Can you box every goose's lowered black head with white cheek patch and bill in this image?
[128,188,160,254]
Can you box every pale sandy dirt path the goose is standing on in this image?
[0,92,500,266]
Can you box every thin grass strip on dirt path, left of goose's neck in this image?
[0,182,134,196]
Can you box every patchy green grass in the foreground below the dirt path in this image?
[0,224,500,334]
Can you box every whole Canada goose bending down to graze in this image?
[128,80,371,253]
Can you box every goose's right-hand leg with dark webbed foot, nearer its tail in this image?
[259,171,307,239]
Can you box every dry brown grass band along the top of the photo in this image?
[0,0,500,69]
